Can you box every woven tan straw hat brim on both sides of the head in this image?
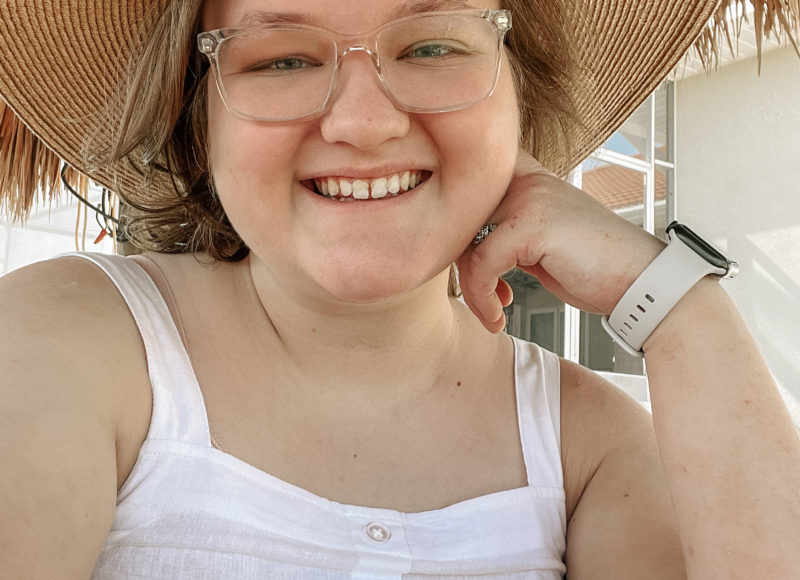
[0,0,792,218]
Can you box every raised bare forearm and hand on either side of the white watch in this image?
[458,153,800,578]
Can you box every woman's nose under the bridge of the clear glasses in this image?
[321,51,410,150]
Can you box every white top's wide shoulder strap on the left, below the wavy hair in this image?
[63,252,211,446]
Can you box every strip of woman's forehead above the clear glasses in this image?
[203,0,500,34]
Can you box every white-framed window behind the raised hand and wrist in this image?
[505,81,675,401]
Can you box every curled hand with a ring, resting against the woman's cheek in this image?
[456,151,664,332]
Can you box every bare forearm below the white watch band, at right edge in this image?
[645,280,800,579]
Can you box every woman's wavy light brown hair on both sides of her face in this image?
[84,0,579,295]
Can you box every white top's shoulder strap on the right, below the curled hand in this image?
[512,337,564,489]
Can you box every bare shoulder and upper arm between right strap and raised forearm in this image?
[561,360,685,579]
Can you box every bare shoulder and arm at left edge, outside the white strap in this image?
[0,257,149,578]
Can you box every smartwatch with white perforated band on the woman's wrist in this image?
[602,222,739,357]
